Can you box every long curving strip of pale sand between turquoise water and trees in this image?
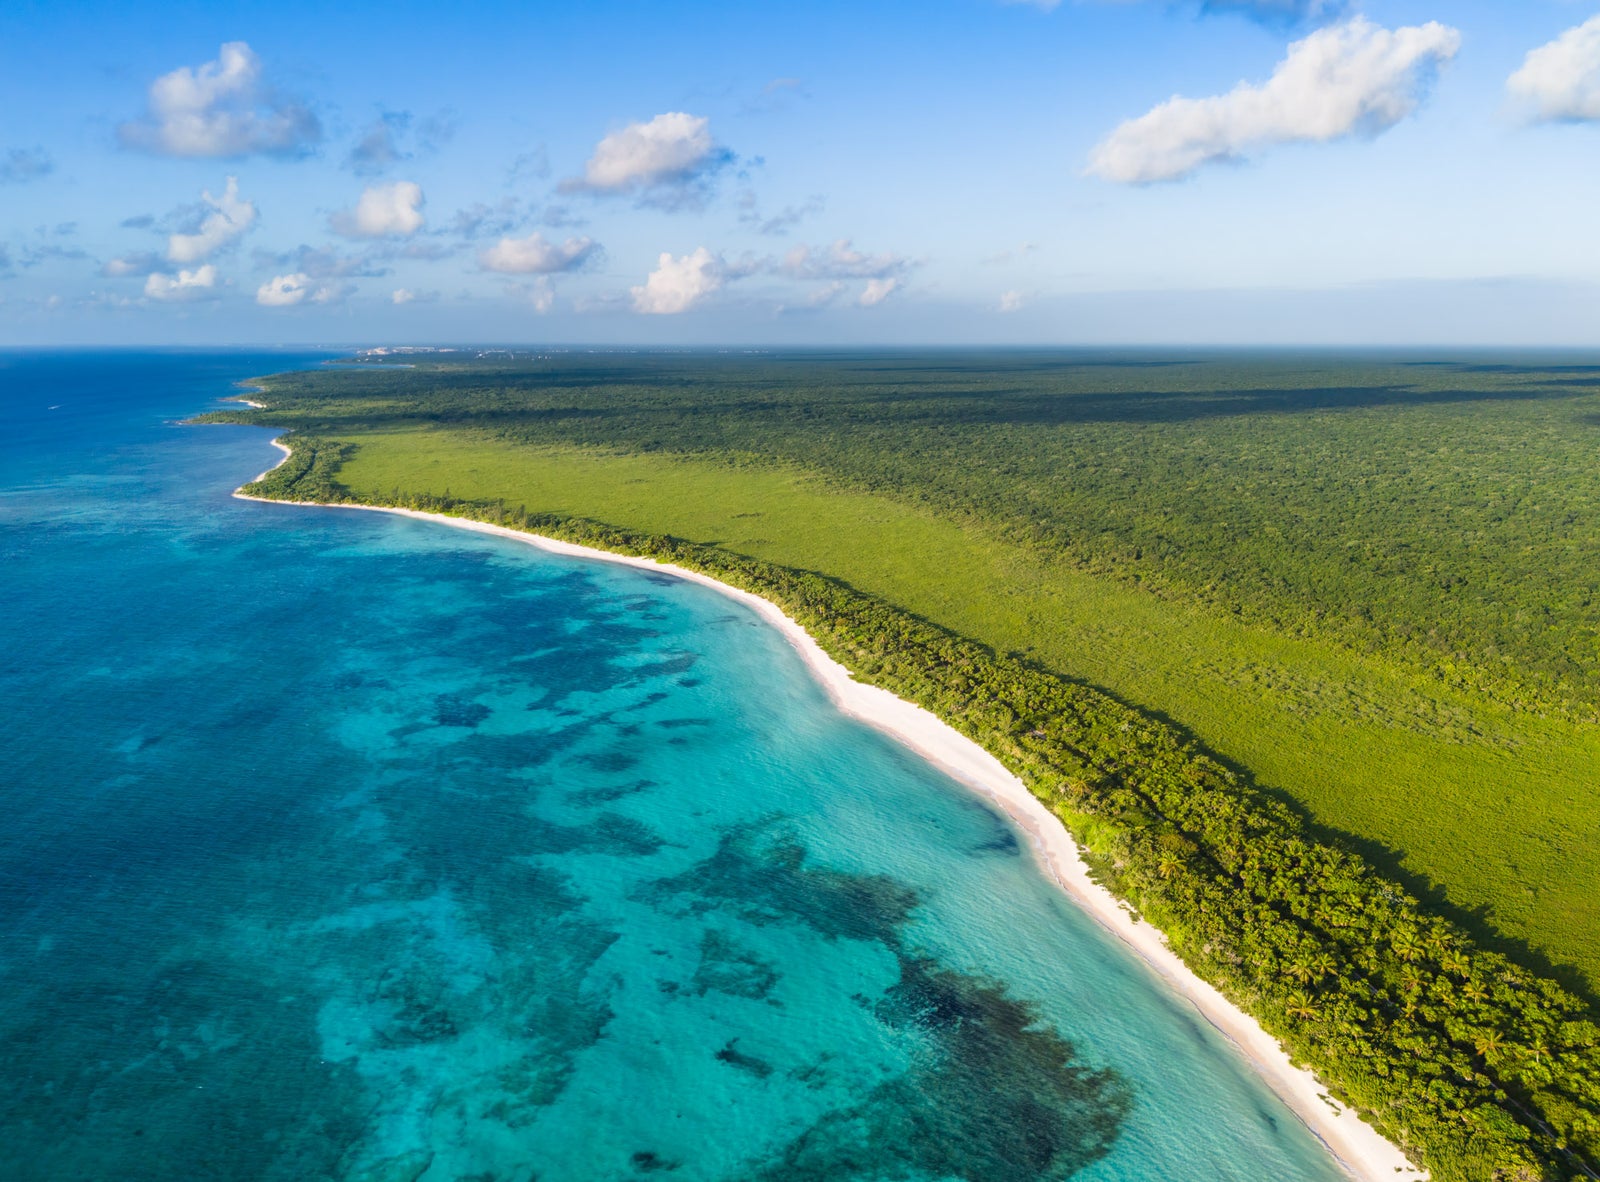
[234,440,1427,1182]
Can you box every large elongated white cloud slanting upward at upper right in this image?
[1090,18,1461,184]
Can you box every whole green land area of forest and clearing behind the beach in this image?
[210,350,1600,1179]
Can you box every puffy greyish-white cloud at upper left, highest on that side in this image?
[118,42,322,157]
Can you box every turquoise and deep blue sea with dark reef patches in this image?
[0,353,1341,1182]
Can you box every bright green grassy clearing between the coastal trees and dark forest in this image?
[328,424,1600,992]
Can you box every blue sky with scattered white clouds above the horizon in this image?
[0,0,1600,347]
